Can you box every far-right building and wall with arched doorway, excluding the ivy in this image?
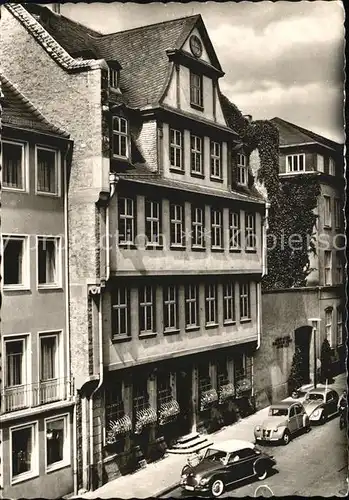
[251,118,346,406]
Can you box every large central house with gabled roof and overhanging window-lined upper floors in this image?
[2,4,266,490]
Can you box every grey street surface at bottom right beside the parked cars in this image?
[162,418,348,498]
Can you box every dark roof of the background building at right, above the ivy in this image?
[271,117,340,149]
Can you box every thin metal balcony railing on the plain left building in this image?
[1,378,70,413]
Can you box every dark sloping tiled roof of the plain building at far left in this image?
[0,75,69,138]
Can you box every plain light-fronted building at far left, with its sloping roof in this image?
[0,75,73,498]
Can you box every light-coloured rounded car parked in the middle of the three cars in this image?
[254,401,310,445]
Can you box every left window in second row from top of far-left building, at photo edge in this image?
[2,236,28,288]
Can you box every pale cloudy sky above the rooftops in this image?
[61,0,344,142]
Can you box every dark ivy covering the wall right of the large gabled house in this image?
[220,94,320,290]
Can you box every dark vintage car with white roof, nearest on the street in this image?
[180,439,276,497]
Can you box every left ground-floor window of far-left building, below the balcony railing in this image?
[10,424,38,480]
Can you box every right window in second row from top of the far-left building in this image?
[38,236,60,286]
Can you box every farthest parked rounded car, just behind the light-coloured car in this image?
[303,387,339,424]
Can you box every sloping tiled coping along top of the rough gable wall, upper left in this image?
[5,3,105,71]
